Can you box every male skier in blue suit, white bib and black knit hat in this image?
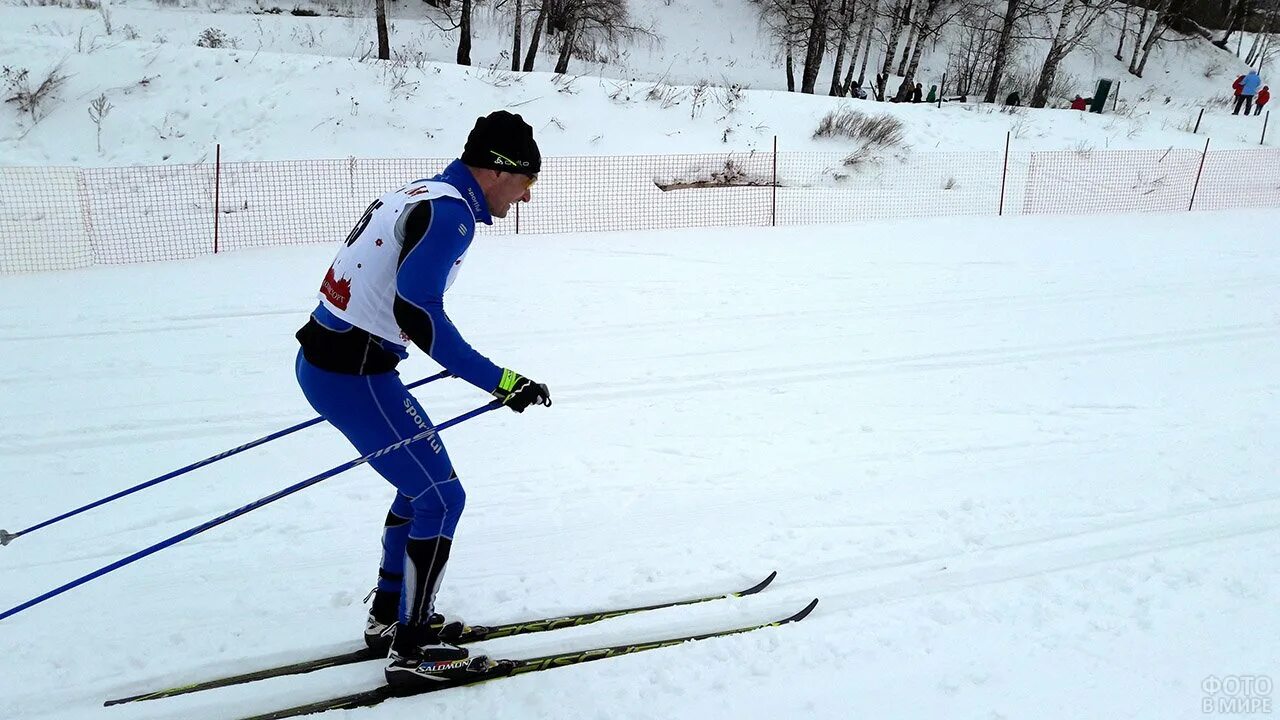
[296,110,552,685]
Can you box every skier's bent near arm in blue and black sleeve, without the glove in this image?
[394,199,502,392]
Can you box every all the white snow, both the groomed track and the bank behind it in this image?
[0,0,1280,720]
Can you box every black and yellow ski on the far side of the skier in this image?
[102,570,778,707]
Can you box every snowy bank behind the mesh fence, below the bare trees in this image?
[0,0,1276,167]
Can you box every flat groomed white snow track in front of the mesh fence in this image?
[0,211,1280,720]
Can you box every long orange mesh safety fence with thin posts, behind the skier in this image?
[0,150,1280,273]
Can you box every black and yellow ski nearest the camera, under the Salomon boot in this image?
[243,598,818,720]
